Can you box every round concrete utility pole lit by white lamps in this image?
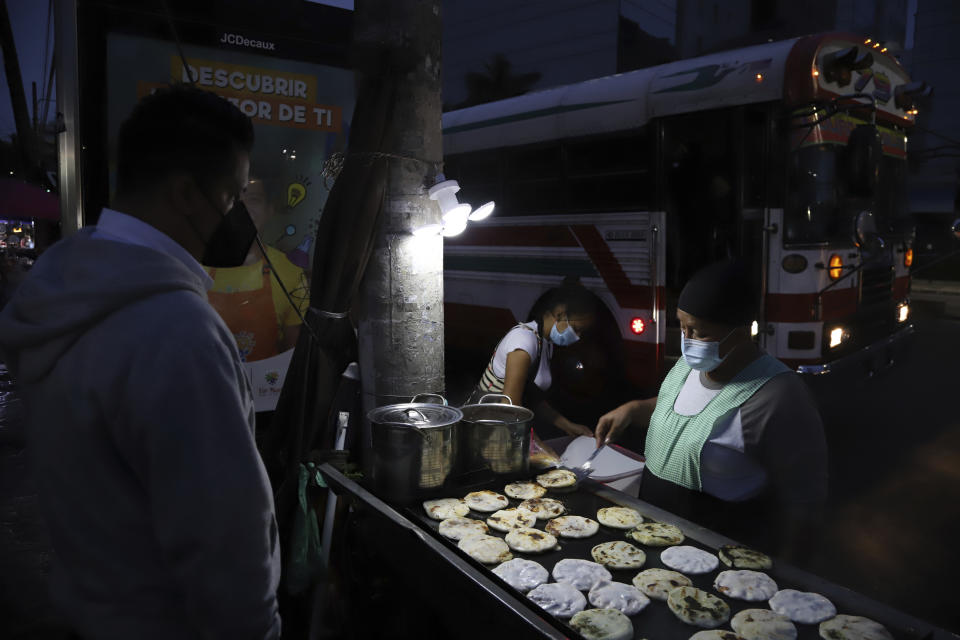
[354,0,444,409]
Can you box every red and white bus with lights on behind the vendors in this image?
[443,33,927,410]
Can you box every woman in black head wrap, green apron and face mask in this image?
[596,260,827,554]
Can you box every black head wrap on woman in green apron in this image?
[677,260,757,326]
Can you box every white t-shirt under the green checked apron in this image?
[673,369,767,501]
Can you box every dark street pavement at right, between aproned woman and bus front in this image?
[805,306,960,633]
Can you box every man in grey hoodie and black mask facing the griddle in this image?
[0,86,280,640]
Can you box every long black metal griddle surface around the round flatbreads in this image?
[320,465,956,640]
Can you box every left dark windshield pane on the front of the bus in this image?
[784,145,844,243]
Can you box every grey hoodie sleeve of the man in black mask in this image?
[117,300,280,639]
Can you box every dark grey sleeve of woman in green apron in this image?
[741,373,827,505]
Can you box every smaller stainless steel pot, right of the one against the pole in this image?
[460,393,533,476]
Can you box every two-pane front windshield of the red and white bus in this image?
[784,144,909,244]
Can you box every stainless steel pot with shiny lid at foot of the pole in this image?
[364,394,463,502]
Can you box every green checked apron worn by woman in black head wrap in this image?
[644,353,790,491]
